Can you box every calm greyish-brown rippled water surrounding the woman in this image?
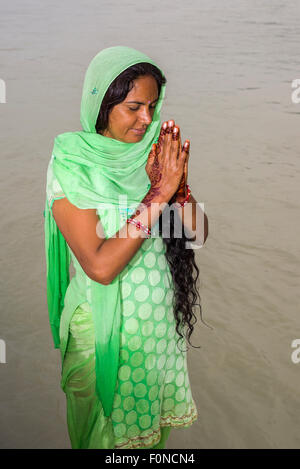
[0,0,300,448]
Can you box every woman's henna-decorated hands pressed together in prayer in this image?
[145,120,189,200]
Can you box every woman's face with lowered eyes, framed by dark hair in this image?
[102,75,159,143]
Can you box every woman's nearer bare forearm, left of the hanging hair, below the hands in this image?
[96,189,170,284]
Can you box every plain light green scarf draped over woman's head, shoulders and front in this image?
[44,46,165,416]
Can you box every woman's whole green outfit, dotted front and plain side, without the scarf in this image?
[49,160,197,449]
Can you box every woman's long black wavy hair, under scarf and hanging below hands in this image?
[95,62,204,348]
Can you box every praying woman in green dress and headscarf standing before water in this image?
[44,46,207,448]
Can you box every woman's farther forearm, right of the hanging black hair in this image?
[176,194,208,248]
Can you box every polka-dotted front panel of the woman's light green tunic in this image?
[108,234,195,448]
